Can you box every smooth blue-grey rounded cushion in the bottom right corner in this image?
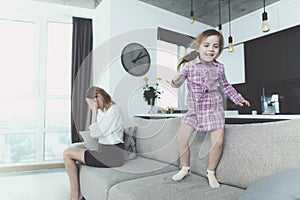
[241,168,300,200]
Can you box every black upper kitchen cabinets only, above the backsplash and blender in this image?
[245,26,300,85]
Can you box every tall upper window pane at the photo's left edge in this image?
[0,20,37,97]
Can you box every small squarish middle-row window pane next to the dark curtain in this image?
[46,99,71,128]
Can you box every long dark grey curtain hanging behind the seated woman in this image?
[71,17,93,143]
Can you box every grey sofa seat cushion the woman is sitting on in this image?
[79,157,178,200]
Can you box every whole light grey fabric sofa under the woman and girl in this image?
[74,118,300,200]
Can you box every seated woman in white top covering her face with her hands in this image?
[64,87,124,200]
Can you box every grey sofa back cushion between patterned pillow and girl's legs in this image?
[133,117,181,166]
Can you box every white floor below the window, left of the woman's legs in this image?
[0,169,70,200]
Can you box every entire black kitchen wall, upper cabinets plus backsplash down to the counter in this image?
[243,26,300,114]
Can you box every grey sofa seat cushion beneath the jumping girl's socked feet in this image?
[109,172,244,200]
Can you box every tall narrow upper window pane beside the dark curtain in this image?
[46,22,72,95]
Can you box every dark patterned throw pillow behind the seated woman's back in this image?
[123,126,137,160]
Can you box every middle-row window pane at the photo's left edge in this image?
[0,99,37,129]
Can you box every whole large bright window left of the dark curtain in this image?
[0,20,72,166]
